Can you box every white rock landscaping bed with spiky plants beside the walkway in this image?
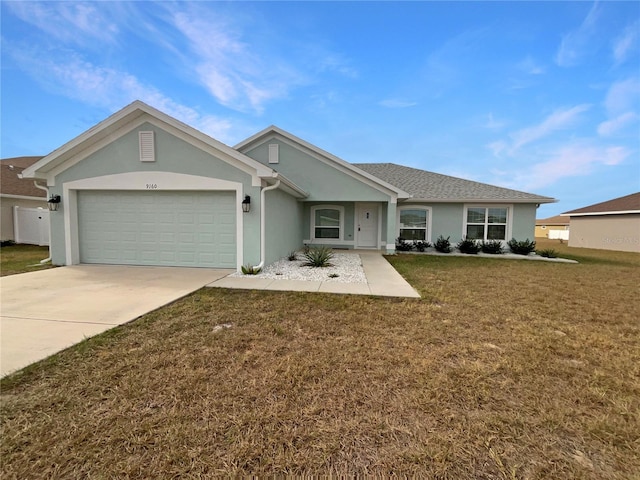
[230,253,367,283]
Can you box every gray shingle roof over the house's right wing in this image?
[354,163,555,203]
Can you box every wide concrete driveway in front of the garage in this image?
[0,265,233,376]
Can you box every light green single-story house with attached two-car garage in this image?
[23,101,554,269]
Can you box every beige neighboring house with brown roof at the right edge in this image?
[562,192,640,252]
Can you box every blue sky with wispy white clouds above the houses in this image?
[1,1,640,218]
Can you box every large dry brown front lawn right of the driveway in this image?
[0,242,640,479]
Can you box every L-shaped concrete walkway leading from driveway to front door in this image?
[207,250,420,298]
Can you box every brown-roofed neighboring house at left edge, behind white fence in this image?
[0,157,48,243]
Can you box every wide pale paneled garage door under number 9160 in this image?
[78,191,236,268]
